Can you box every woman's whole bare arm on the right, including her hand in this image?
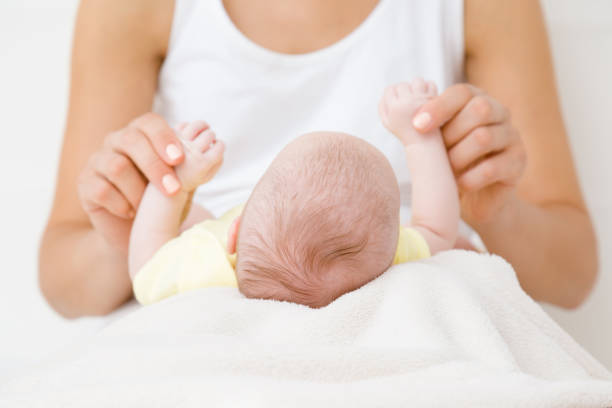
[422,0,597,308]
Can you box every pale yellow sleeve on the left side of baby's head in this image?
[133,221,237,305]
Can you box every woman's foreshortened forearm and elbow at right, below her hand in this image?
[473,196,598,308]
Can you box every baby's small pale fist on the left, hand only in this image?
[174,121,225,193]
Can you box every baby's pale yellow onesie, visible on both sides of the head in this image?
[133,205,430,305]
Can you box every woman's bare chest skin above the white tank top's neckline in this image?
[223,0,379,54]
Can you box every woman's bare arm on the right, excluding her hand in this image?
[465,0,597,308]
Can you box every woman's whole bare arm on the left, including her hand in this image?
[39,0,175,317]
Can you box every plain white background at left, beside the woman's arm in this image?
[0,0,112,381]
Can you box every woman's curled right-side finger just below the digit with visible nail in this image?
[442,94,510,147]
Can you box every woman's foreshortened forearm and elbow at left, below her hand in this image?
[39,224,132,318]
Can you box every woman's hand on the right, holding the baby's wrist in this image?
[413,84,527,224]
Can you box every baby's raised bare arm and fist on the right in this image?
[380,79,460,254]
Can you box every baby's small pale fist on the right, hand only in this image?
[378,78,439,146]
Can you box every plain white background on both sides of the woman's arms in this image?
[0,0,612,381]
